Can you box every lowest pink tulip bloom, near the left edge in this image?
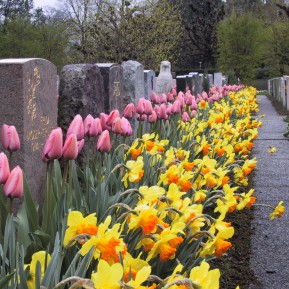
[4,166,23,198]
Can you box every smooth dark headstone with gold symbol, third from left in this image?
[96,63,124,113]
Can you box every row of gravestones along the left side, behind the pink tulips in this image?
[0,59,222,203]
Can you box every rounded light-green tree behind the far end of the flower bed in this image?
[218,14,266,84]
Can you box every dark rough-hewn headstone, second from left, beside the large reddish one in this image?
[58,64,105,131]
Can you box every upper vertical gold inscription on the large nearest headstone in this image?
[27,67,40,121]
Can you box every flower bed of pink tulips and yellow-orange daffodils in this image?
[0,86,284,289]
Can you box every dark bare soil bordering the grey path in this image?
[211,95,289,289]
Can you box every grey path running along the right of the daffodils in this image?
[249,95,289,289]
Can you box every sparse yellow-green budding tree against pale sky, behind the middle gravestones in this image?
[61,0,181,69]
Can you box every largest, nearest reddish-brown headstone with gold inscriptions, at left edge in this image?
[0,58,57,204]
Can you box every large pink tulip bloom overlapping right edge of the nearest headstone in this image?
[41,127,63,162]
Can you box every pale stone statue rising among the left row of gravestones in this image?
[155,61,174,95]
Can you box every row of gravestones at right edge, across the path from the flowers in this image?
[268,76,289,110]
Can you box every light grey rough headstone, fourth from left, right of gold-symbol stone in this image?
[122,60,144,106]
